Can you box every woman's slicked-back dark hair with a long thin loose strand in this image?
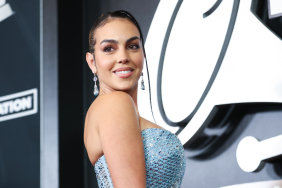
[89,10,156,122]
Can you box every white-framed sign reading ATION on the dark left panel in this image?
[0,89,37,122]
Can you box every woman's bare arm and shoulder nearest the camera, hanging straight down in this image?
[93,91,146,188]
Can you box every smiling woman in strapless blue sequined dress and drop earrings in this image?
[84,11,186,188]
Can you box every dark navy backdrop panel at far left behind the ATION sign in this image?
[0,0,40,188]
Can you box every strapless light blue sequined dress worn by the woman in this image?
[94,128,186,188]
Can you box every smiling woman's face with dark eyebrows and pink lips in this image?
[87,19,144,91]
